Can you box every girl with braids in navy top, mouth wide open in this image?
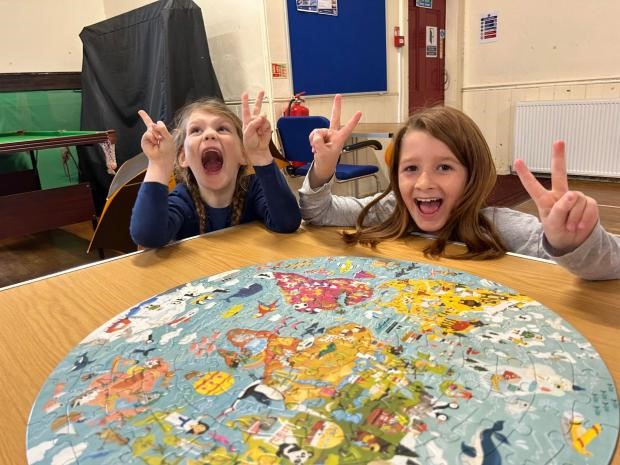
[130,91,301,247]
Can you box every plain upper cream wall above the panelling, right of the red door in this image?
[463,0,620,87]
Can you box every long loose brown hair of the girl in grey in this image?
[342,106,506,259]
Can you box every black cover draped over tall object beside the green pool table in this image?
[78,0,222,212]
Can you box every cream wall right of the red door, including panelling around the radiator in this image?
[460,0,620,174]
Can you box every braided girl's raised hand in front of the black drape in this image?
[138,110,176,184]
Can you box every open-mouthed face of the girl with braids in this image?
[179,109,245,208]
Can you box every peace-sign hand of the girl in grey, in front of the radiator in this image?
[514,141,599,254]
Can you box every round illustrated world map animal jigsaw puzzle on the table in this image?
[27,257,619,465]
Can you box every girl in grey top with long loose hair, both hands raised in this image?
[299,92,620,279]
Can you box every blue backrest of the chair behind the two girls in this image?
[276,116,329,164]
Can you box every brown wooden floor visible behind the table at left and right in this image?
[0,180,620,287]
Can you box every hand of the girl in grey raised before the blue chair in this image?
[309,94,362,189]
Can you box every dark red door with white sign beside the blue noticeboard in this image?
[408,0,446,113]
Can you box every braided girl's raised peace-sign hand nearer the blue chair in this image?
[241,90,273,166]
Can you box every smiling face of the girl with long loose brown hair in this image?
[398,130,467,233]
